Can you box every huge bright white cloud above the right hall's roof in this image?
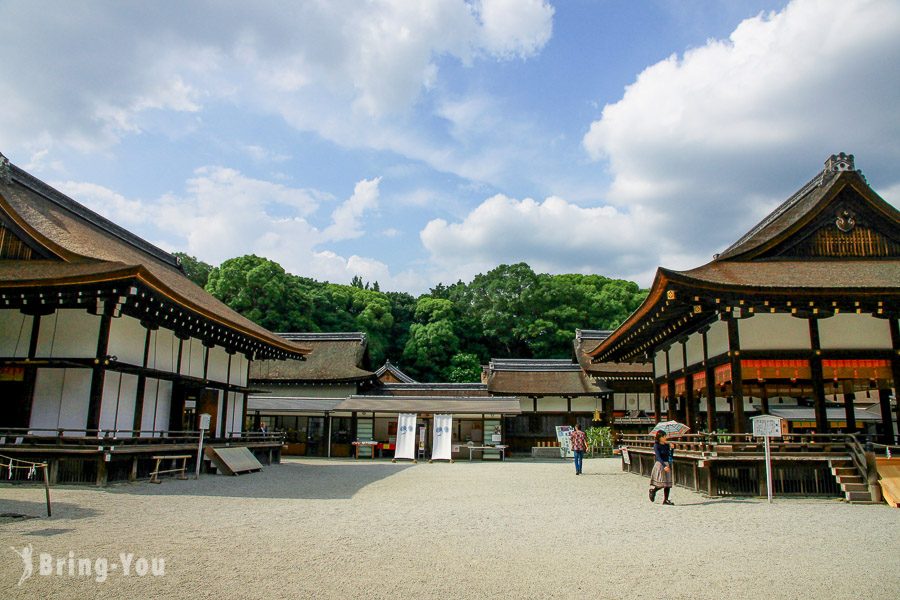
[583,0,900,253]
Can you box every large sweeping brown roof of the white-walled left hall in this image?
[0,155,308,358]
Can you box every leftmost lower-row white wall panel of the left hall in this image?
[30,369,91,435]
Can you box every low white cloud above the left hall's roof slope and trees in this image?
[54,167,408,289]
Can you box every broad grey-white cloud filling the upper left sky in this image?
[0,0,553,179]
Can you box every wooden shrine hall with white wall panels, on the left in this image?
[0,155,309,480]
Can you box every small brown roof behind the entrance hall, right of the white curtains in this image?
[482,358,609,396]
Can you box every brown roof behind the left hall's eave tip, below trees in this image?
[250,331,375,383]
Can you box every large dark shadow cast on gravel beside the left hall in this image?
[106,460,413,500]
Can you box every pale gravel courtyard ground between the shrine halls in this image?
[0,459,900,600]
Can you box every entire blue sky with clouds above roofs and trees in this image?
[0,0,900,292]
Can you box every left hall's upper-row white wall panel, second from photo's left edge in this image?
[37,308,103,358]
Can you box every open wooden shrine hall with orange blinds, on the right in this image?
[589,154,900,443]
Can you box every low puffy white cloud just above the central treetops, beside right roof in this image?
[420,195,658,281]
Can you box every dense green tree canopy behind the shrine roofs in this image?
[202,255,647,382]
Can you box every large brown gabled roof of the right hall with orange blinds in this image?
[587,154,900,362]
